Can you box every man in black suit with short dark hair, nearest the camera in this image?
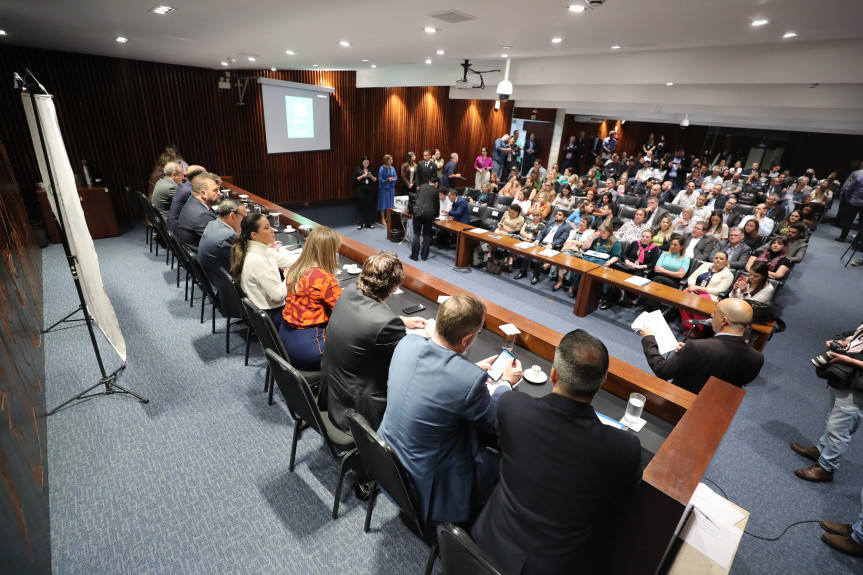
[471,329,641,575]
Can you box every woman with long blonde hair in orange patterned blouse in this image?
[279,227,342,371]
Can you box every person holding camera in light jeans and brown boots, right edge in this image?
[791,325,863,482]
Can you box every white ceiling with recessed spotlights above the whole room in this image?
[0,0,863,133]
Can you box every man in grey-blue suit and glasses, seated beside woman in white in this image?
[198,200,246,317]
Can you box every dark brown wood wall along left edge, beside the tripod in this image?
[0,143,51,574]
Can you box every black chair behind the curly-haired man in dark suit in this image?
[267,349,360,519]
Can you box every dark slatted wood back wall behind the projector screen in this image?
[0,47,512,223]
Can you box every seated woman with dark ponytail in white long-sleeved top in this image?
[231,214,300,329]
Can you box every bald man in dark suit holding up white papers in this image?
[641,298,764,394]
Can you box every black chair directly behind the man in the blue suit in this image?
[346,410,437,575]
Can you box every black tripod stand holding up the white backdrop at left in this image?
[14,70,150,415]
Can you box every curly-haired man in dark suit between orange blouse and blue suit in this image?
[321,252,426,434]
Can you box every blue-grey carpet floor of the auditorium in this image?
[43,206,863,574]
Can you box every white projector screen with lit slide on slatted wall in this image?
[258,78,335,154]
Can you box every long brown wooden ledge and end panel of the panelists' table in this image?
[219,180,745,574]
